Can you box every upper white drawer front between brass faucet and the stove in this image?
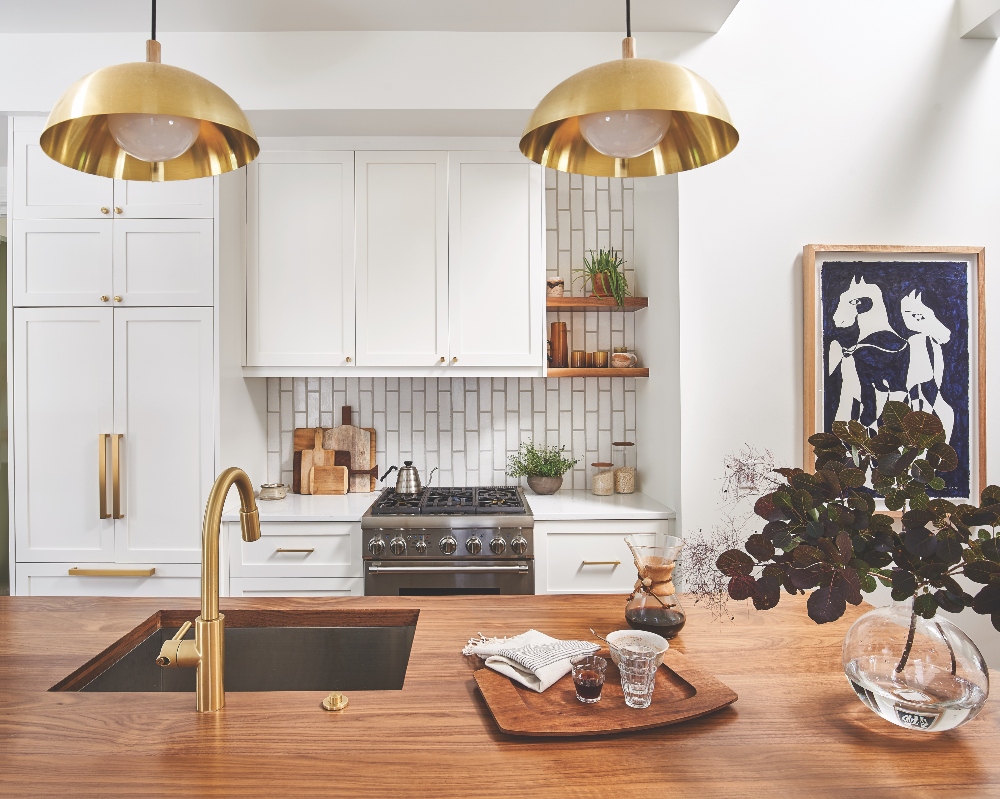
[229,522,363,577]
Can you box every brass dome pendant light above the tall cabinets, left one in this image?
[40,0,260,181]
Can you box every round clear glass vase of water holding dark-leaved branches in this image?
[843,597,990,732]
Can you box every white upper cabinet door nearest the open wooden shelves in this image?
[448,152,545,366]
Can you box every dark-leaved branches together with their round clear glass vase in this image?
[717,402,1000,731]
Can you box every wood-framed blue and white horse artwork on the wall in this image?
[802,244,986,504]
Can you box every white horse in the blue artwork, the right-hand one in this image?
[899,289,955,441]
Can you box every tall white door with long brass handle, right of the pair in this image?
[114,308,215,563]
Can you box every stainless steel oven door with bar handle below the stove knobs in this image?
[365,558,535,596]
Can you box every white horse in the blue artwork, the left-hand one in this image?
[828,277,909,432]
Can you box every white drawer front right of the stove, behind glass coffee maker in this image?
[546,533,636,594]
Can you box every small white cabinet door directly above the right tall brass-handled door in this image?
[114,219,215,306]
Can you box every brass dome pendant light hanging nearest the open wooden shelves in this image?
[520,0,740,177]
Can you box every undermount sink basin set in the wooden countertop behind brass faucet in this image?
[50,609,419,692]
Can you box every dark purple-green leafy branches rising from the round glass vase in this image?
[716,402,1000,670]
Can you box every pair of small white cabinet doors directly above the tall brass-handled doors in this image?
[11,219,215,307]
